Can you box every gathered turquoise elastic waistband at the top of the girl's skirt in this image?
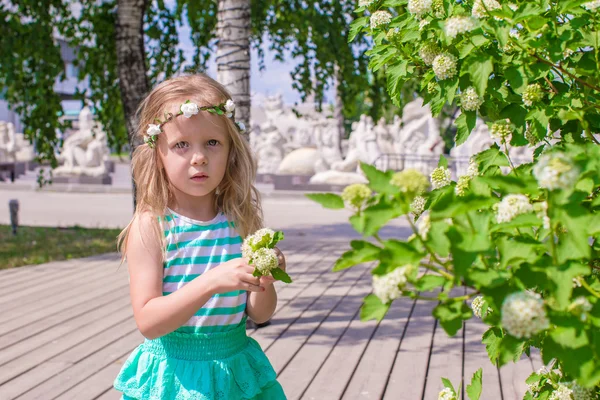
[142,318,248,361]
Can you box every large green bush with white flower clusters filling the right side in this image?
[309,0,600,399]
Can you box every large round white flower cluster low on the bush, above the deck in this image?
[501,292,550,338]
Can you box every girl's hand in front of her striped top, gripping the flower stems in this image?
[205,258,265,293]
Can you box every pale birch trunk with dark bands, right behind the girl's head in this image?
[216,0,251,139]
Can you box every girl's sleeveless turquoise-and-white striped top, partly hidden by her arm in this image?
[161,209,247,333]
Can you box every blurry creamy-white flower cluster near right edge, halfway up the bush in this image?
[533,153,579,190]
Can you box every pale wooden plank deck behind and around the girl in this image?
[0,241,541,400]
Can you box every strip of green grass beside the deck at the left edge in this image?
[0,225,121,269]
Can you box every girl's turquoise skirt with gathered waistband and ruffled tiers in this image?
[114,319,286,400]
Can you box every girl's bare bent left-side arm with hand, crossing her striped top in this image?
[127,213,262,339]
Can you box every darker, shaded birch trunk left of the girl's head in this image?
[116,0,149,148]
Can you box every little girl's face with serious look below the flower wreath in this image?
[158,111,230,201]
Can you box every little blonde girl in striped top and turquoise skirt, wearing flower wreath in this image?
[114,75,285,400]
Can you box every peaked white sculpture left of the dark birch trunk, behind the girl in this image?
[53,107,110,177]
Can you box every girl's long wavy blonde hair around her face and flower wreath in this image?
[117,74,262,258]
